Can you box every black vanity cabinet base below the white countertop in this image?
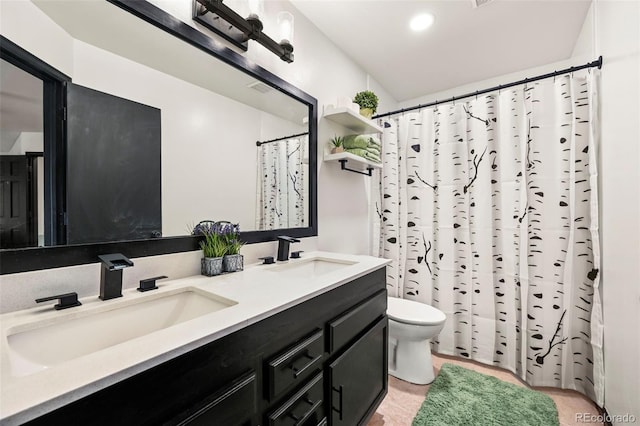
[23,268,387,426]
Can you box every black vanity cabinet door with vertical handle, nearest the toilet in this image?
[329,316,387,426]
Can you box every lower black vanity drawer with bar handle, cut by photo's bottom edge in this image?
[267,373,326,426]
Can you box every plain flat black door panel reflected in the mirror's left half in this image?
[66,83,162,244]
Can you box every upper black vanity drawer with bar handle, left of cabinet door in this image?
[267,329,324,400]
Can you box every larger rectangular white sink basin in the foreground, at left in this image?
[7,287,237,376]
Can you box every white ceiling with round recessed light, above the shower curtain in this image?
[291,0,591,102]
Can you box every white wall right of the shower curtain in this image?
[593,0,640,424]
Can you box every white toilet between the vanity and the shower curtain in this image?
[387,297,447,385]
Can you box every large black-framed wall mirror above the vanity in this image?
[0,0,317,274]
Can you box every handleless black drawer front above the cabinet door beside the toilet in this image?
[327,290,387,353]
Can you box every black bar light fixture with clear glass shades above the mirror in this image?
[193,0,293,63]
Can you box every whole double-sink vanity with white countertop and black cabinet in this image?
[0,252,387,426]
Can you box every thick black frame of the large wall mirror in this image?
[0,0,318,275]
